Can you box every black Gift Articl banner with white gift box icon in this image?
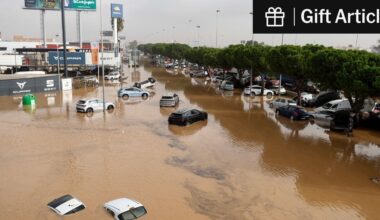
[253,0,380,34]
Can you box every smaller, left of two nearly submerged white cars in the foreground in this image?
[48,195,86,215]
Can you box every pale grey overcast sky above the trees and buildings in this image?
[0,0,380,49]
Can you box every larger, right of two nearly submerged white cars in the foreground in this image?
[104,198,147,220]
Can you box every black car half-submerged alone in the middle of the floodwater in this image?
[168,109,208,126]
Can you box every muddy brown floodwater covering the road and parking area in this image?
[0,62,380,220]
